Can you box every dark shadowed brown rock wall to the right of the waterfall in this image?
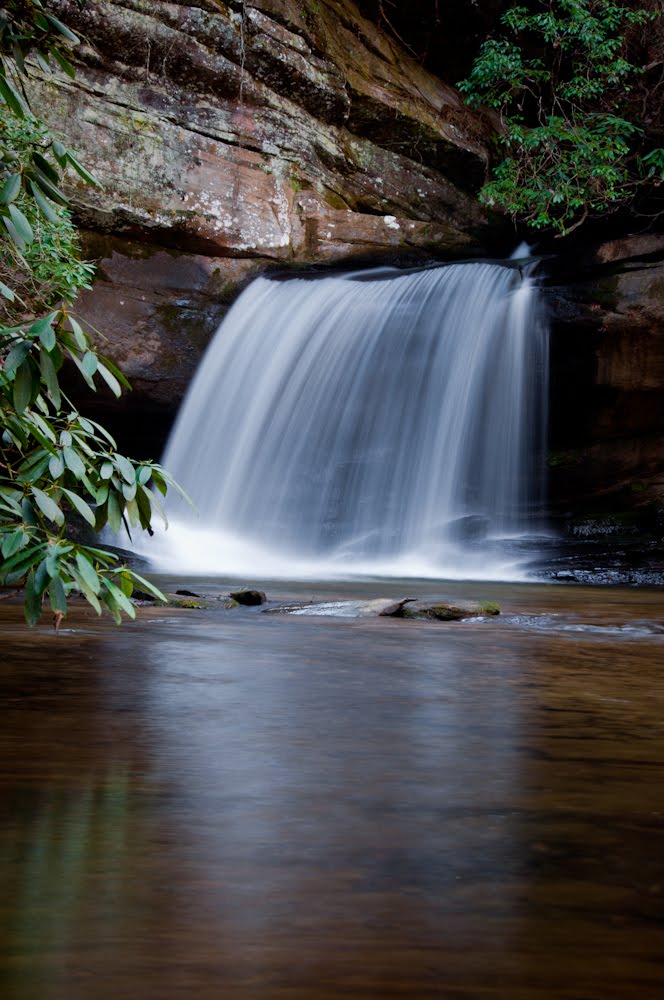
[547,232,664,512]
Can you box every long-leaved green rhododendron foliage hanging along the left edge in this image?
[0,0,184,625]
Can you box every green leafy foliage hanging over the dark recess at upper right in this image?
[459,0,664,233]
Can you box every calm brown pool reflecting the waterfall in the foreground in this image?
[0,581,664,1000]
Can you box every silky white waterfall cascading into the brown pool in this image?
[150,263,547,579]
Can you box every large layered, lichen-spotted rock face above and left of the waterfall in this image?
[31,0,496,430]
